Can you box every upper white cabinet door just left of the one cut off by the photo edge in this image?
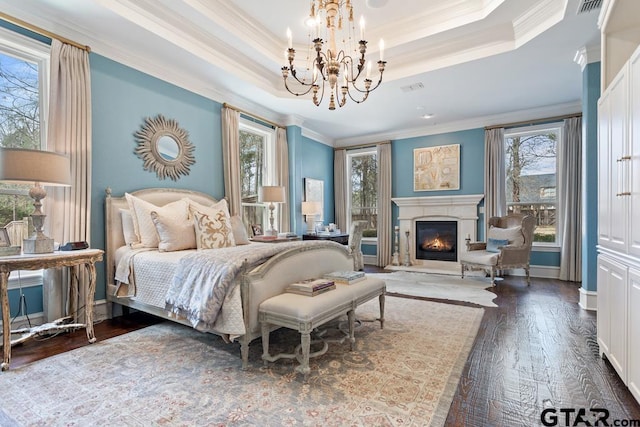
[607,68,629,253]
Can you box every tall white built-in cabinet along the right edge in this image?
[597,36,640,401]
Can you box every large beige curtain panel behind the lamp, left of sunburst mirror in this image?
[43,39,91,320]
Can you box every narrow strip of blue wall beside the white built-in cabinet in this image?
[582,62,600,291]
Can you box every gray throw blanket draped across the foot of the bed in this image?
[165,241,336,331]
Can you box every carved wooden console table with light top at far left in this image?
[0,249,104,371]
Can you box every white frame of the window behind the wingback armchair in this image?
[504,122,564,252]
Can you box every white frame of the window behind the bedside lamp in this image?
[238,115,279,231]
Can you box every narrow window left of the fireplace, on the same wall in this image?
[347,148,378,238]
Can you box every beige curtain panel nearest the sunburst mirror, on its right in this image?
[221,107,242,216]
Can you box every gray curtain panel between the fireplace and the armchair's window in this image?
[484,128,507,226]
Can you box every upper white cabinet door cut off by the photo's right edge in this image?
[626,48,640,257]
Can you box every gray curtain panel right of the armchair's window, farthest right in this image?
[558,117,582,282]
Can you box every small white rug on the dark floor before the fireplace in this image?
[367,271,497,307]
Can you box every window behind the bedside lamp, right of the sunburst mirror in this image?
[240,119,277,236]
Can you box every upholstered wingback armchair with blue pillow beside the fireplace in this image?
[460,214,536,286]
